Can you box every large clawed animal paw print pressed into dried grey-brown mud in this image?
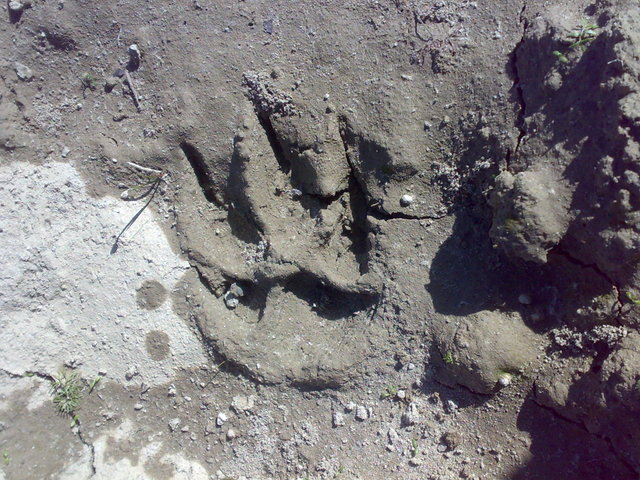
[180,107,381,388]
